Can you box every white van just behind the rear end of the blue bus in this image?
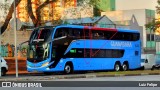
[141,54,155,70]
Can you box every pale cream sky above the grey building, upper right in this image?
[116,0,157,10]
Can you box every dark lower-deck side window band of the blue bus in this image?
[65,48,124,58]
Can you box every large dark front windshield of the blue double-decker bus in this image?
[27,28,54,61]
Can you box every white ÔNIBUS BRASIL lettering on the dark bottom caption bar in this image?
[11,82,42,87]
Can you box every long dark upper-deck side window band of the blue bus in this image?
[55,28,140,41]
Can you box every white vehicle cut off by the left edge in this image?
[0,57,8,76]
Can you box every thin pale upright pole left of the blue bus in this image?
[14,0,18,77]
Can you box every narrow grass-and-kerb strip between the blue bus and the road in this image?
[0,70,160,81]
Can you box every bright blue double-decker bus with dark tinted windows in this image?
[27,25,141,74]
